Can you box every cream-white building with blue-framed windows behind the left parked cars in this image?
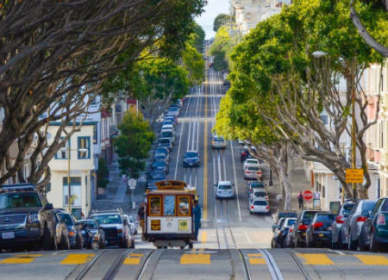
[47,122,97,217]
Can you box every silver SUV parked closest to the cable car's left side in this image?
[89,209,135,248]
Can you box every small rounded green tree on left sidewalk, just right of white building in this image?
[114,110,155,179]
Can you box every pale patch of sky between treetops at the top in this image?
[196,0,230,39]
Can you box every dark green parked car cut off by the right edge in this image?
[359,197,388,251]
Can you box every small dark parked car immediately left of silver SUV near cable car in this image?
[76,219,106,249]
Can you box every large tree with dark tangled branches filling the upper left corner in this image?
[0,0,203,188]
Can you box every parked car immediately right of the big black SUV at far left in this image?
[54,209,84,249]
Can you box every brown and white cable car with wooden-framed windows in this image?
[144,180,196,249]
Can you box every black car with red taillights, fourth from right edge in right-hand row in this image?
[306,212,335,247]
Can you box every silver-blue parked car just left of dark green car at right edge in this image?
[342,199,376,250]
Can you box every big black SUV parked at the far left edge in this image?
[0,184,56,249]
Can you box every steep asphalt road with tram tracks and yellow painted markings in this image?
[0,49,388,280]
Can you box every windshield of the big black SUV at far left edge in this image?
[0,192,42,210]
